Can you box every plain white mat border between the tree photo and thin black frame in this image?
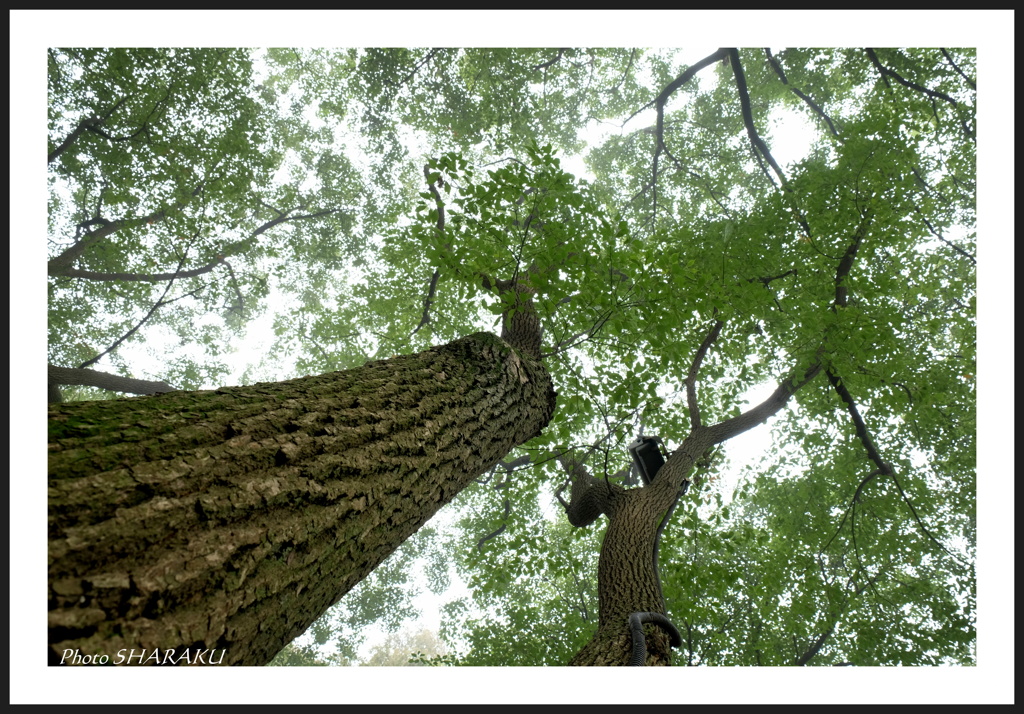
[8,10,1014,704]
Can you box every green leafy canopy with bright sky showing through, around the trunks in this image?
[48,48,976,665]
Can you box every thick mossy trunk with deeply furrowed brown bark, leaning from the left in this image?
[49,333,554,665]
